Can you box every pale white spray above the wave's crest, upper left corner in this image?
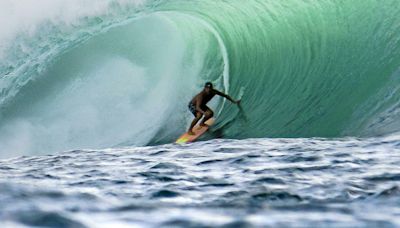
[0,0,145,57]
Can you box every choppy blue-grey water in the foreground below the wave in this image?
[0,137,400,227]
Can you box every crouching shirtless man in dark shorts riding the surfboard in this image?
[188,82,240,135]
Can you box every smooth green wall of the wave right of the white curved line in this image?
[157,0,400,137]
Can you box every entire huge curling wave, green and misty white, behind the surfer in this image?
[0,0,400,155]
